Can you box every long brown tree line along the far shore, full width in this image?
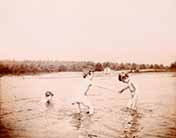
[0,60,176,75]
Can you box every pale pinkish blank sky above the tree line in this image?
[0,0,176,65]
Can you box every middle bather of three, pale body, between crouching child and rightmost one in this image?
[72,71,94,114]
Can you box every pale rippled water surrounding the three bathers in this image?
[0,73,176,138]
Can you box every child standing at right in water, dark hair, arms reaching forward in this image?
[118,73,137,110]
